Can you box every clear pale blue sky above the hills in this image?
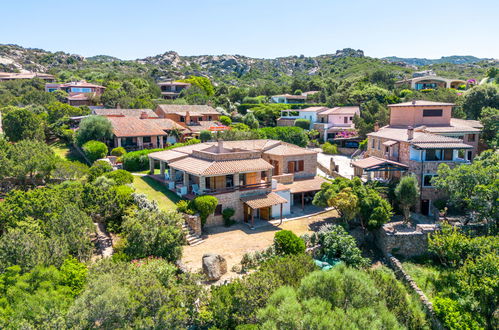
[0,0,499,59]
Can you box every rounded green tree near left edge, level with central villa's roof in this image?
[8,140,58,185]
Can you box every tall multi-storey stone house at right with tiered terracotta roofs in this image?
[351,101,482,215]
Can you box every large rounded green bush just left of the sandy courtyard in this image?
[122,210,183,262]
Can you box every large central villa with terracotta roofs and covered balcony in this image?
[148,140,324,225]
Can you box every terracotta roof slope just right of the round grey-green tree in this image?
[107,117,167,137]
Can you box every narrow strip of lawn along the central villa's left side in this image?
[133,175,180,210]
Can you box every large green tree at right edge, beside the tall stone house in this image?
[433,150,499,232]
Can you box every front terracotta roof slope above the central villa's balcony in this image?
[169,157,274,175]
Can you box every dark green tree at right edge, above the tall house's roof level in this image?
[461,84,499,119]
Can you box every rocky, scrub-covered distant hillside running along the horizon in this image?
[0,45,494,86]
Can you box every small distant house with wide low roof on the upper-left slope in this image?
[45,80,106,106]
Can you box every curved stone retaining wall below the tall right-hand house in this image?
[374,222,438,258]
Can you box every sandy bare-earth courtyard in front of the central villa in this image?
[182,211,337,280]
